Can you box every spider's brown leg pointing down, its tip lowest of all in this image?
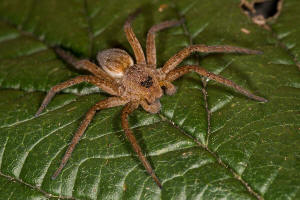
[122,103,162,188]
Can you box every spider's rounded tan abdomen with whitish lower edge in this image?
[97,49,134,78]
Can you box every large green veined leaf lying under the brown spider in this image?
[0,0,300,199]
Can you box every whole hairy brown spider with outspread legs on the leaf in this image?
[35,12,267,188]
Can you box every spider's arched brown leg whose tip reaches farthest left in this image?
[35,76,120,117]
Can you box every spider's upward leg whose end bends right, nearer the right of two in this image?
[146,19,184,68]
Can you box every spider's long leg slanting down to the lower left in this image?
[52,97,128,179]
